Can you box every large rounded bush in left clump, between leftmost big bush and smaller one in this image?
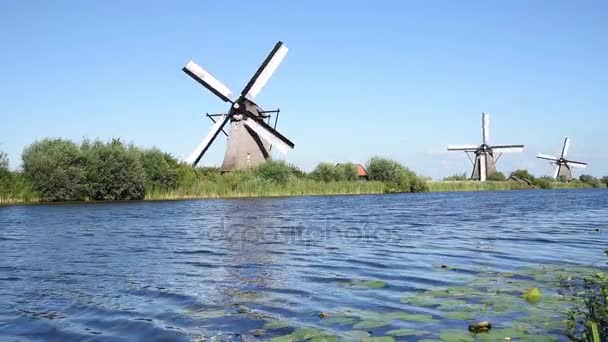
[82,140,146,201]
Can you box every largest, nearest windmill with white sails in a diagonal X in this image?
[182,42,294,171]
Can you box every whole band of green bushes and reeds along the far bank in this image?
[0,139,608,204]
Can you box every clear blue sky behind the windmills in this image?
[0,0,608,178]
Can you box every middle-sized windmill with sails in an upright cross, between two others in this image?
[448,113,524,182]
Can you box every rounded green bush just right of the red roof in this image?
[367,157,428,192]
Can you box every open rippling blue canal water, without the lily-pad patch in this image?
[0,189,608,341]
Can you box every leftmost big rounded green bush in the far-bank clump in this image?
[22,139,87,201]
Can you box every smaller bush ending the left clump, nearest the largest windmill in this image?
[138,148,177,190]
